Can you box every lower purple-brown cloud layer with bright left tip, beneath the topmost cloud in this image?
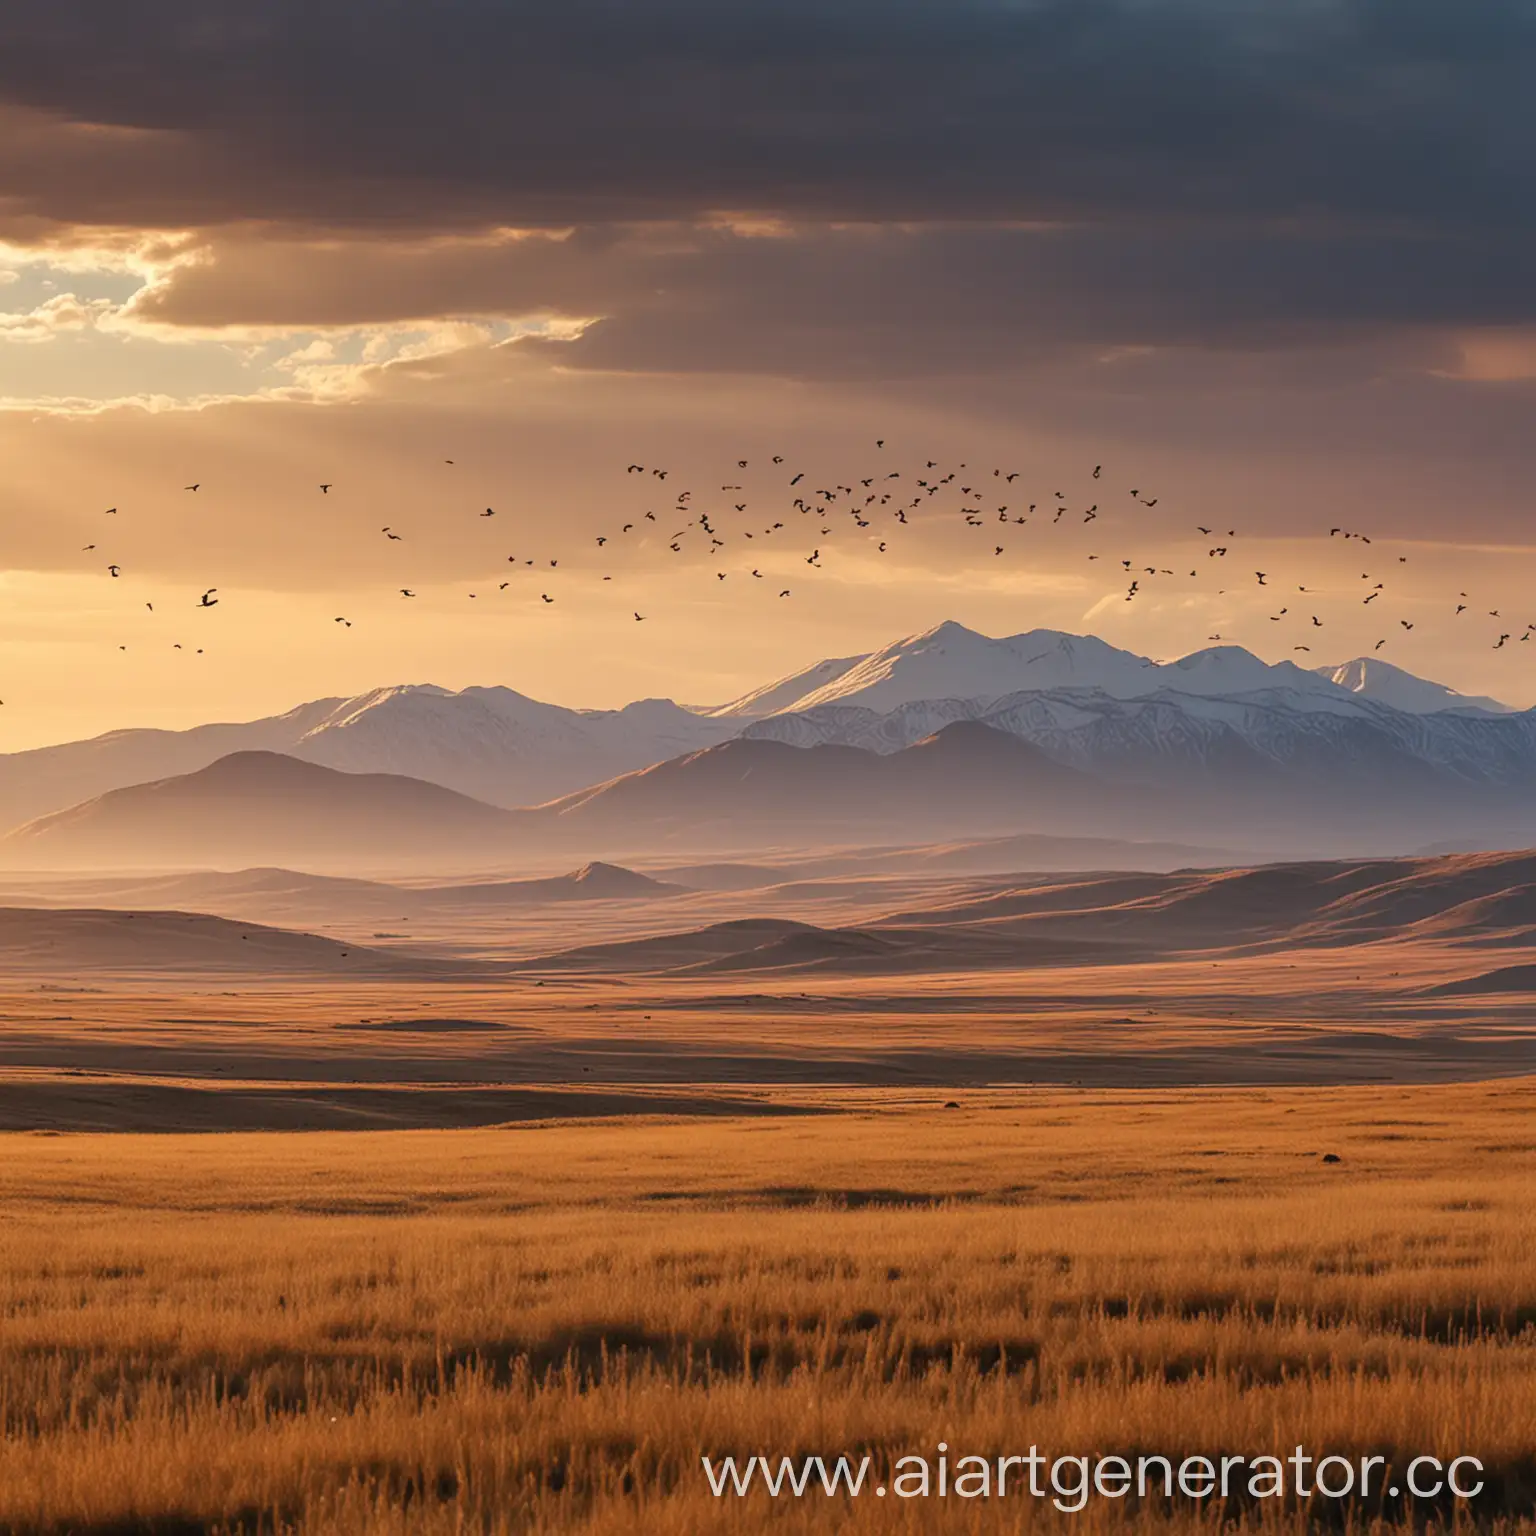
[132,224,1536,378]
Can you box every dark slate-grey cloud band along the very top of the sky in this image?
[0,0,1536,232]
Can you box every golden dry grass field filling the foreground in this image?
[0,1081,1536,1536]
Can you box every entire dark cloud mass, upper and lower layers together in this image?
[0,0,1536,365]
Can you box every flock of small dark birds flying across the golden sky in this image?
[48,438,1536,688]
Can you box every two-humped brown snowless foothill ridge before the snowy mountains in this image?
[0,734,1100,878]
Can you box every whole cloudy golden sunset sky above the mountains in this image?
[0,0,1536,750]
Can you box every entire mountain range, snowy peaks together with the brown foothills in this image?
[0,624,1536,868]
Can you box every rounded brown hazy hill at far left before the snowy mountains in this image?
[0,753,518,869]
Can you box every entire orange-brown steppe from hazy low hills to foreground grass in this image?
[0,856,1536,1536]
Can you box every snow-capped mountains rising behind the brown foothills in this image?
[0,624,1511,841]
